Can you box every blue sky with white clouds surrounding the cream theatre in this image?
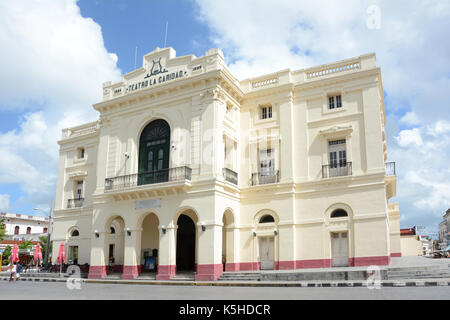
[0,0,450,236]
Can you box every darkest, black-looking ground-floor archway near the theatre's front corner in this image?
[177,214,196,271]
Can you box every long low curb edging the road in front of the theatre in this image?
[0,277,450,289]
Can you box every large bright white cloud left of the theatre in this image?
[0,0,120,211]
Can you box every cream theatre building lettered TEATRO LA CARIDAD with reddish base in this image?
[52,48,401,280]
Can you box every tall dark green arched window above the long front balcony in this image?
[138,119,170,185]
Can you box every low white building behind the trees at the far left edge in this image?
[0,212,49,241]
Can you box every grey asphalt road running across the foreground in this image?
[0,281,450,300]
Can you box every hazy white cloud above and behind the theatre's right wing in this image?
[196,0,450,235]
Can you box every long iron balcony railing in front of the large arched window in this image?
[105,167,192,192]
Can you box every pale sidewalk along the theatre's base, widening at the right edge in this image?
[0,256,450,287]
